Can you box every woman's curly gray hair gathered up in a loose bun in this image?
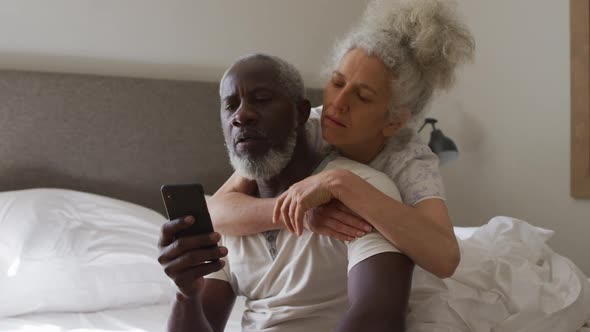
[328,0,475,127]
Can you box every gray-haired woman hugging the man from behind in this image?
[209,0,474,278]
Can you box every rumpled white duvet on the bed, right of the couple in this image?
[409,217,590,332]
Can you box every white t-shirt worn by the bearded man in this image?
[207,154,400,332]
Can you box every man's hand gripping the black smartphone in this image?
[158,216,227,299]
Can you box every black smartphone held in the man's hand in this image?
[161,183,213,237]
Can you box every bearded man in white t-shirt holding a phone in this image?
[159,54,413,332]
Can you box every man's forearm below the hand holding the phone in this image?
[168,295,214,332]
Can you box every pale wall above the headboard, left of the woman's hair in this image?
[0,0,365,87]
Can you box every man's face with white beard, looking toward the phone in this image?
[221,60,297,179]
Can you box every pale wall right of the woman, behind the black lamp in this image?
[424,0,590,275]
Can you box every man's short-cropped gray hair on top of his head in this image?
[219,53,305,102]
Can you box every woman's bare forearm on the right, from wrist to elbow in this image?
[333,171,460,278]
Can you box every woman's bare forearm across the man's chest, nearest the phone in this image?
[207,192,283,236]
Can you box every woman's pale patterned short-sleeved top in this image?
[306,106,445,206]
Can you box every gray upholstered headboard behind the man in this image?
[0,71,321,211]
